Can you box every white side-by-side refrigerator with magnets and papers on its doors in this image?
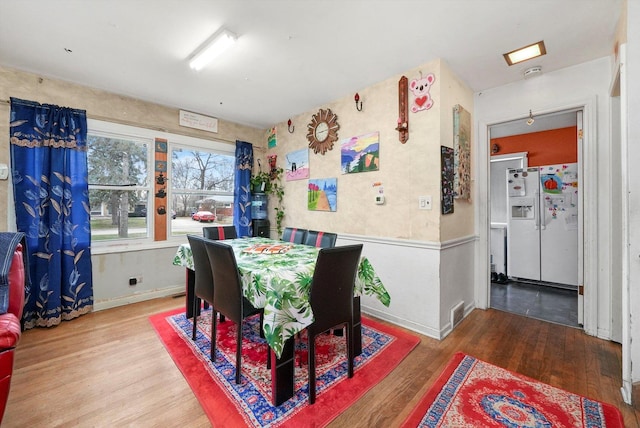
[507,163,578,286]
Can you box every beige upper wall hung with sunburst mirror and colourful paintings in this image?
[262,60,474,242]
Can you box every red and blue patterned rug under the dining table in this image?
[149,310,420,427]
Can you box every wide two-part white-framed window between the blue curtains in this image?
[87,119,235,245]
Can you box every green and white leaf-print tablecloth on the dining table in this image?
[173,238,391,357]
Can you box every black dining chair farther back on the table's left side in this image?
[187,235,224,352]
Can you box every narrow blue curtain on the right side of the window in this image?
[233,141,253,236]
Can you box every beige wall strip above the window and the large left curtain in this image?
[0,67,264,230]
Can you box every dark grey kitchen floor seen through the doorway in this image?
[491,281,580,327]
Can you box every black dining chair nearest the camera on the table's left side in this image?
[205,241,264,384]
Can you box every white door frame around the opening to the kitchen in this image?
[475,96,598,336]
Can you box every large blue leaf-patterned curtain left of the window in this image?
[10,98,93,328]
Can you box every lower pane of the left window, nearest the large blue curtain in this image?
[89,189,149,241]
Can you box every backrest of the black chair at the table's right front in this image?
[309,244,362,332]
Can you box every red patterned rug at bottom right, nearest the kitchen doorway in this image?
[403,353,624,428]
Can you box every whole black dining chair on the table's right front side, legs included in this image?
[307,244,362,404]
